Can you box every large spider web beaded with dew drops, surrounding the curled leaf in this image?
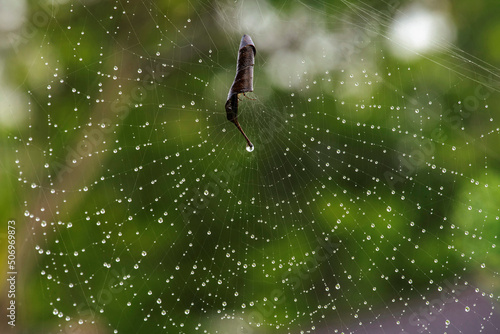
[11,1,500,333]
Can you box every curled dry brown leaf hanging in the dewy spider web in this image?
[226,35,257,148]
